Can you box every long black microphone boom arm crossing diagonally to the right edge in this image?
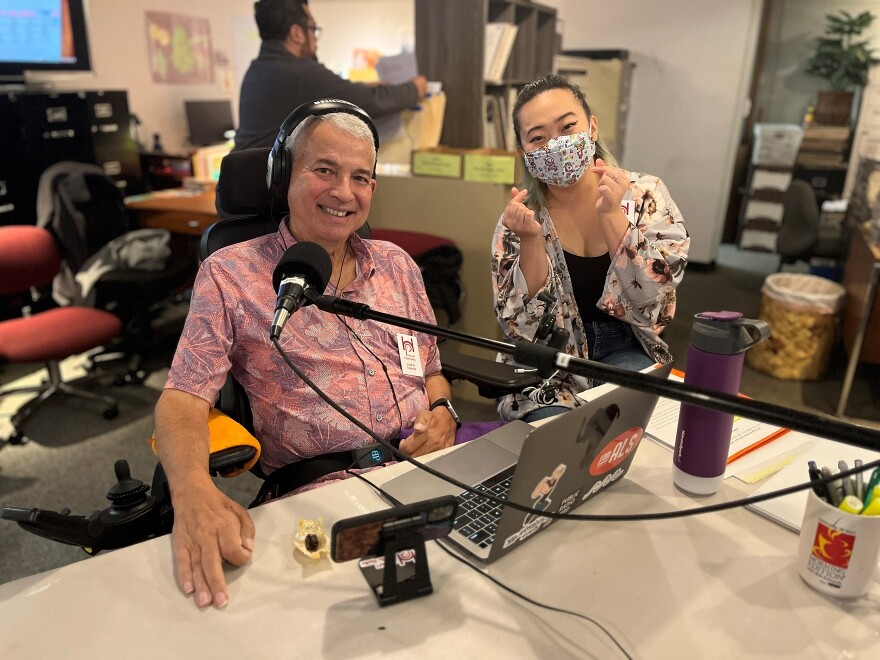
[306,291,880,451]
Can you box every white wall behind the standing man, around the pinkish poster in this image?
[31,0,414,152]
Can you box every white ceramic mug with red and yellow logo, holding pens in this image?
[797,490,880,598]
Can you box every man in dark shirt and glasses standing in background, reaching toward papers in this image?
[235,0,427,150]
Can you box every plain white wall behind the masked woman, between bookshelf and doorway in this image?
[542,0,761,263]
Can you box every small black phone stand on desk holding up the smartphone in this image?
[359,519,434,607]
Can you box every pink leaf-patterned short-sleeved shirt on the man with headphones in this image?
[165,222,440,483]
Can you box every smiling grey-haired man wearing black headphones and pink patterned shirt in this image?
[155,100,460,607]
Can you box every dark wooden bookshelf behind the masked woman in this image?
[415,0,558,148]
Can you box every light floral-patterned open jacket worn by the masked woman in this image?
[492,173,690,419]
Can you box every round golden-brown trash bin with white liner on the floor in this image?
[746,273,846,380]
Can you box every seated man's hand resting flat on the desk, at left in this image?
[172,475,254,607]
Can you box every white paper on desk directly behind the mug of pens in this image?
[747,438,880,532]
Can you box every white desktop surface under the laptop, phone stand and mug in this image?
[0,440,880,659]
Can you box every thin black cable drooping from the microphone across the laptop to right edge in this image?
[272,338,880,522]
